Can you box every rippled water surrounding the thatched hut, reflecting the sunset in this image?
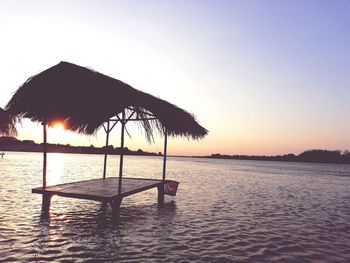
[0,153,350,262]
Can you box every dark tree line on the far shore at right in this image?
[206,150,350,164]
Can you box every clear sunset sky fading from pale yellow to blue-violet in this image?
[0,0,350,154]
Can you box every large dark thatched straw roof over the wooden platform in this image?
[6,62,208,140]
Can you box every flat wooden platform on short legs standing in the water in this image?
[32,177,164,217]
